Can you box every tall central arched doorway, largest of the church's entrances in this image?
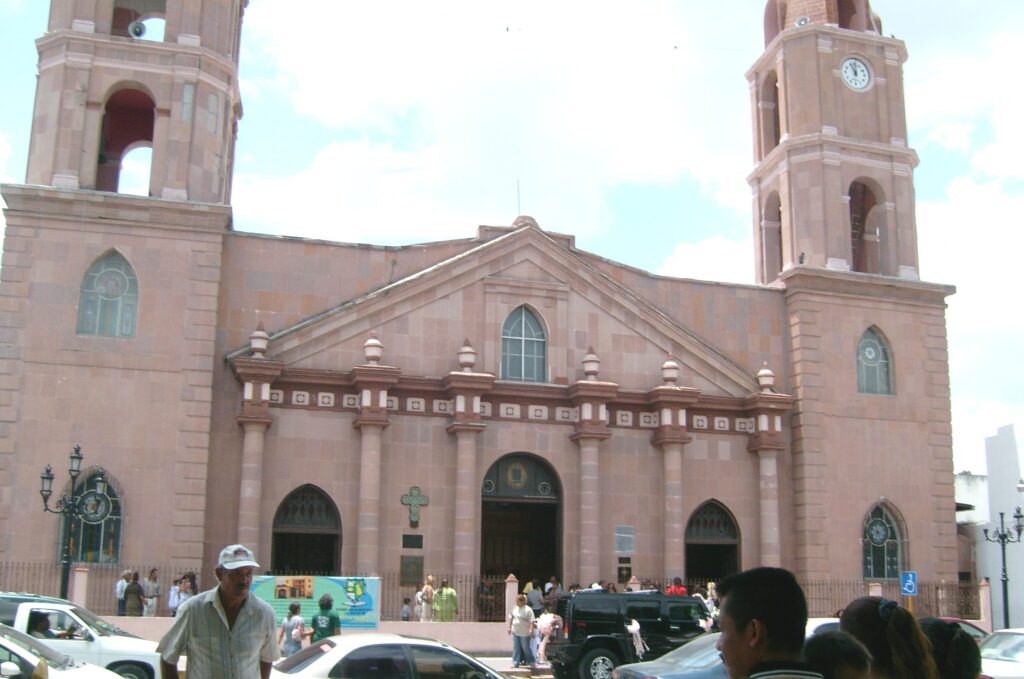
[480,453,562,582]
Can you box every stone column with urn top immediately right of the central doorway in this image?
[568,347,618,587]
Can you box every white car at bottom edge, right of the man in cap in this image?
[270,632,506,679]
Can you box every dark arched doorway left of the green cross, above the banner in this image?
[270,483,341,576]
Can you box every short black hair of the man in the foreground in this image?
[718,566,807,653]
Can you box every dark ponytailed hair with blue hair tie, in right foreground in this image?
[839,596,939,679]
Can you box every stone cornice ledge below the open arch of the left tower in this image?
[0,184,231,235]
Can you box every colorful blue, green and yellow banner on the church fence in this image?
[252,576,381,630]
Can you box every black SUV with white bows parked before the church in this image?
[546,590,706,679]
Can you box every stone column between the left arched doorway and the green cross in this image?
[352,337,401,576]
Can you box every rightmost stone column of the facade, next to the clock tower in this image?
[744,364,793,566]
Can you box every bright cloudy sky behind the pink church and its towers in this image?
[0,0,1024,473]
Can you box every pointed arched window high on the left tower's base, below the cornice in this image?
[78,250,138,337]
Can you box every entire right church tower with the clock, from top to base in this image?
[746,0,956,580]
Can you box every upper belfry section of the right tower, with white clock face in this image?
[746,0,919,284]
